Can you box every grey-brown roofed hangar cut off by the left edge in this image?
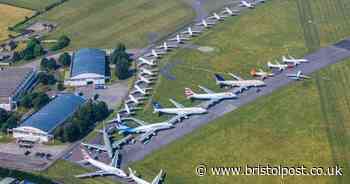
[0,68,37,111]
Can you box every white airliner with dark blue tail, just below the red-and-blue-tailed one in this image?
[153,99,207,118]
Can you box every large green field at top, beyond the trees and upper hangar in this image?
[17,0,194,48]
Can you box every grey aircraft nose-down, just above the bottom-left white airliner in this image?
[81,125,113,158]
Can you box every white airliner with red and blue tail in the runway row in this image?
[185,86,237,105]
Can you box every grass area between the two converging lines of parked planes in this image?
[133,0,350,120]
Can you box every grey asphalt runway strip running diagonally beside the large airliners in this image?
[121,39,350,167]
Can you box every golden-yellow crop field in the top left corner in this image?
[0,4,33,41]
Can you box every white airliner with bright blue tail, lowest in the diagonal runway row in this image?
[117,118,174,142]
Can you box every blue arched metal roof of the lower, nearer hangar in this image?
[20,93,86,133]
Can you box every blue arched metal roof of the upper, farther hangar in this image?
[71,48,106,77]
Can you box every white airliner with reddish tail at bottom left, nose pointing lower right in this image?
[75,149,128,178]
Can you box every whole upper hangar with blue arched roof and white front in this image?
[64,48,109,86]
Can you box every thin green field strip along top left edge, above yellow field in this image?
[0,0,58,10]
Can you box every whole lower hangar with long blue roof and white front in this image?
[12,93,86,143]
